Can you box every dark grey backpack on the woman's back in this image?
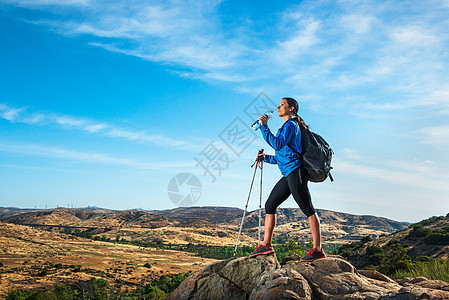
[287,120,334,182]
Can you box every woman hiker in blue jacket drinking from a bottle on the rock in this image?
[250,98,326,261]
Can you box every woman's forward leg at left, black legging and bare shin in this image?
[262,177,291,245]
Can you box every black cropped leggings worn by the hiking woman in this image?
[265,165,315,217]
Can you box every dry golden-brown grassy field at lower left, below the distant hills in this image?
[0,222,215,298]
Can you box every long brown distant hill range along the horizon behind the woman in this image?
[0,206,408,245]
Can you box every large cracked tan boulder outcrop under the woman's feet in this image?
[166,255,449,300]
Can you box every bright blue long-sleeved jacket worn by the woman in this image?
[260,117,302,177]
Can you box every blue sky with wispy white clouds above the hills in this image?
[0,0,449,222]
